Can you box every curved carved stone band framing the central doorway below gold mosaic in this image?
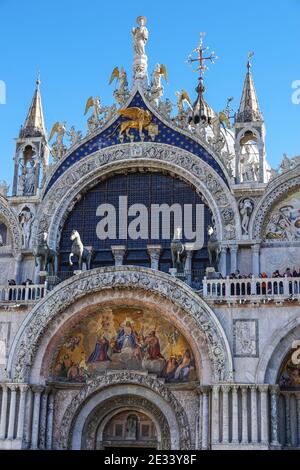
[59,371,191,450]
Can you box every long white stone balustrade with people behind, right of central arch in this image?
[203,277,300,303]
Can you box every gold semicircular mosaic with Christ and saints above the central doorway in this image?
[51,306,197,383]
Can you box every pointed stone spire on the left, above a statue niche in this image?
[20,73,46,138]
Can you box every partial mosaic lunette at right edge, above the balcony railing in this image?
[263,190,300,241]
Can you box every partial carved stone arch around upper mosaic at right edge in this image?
[250,165,300,240]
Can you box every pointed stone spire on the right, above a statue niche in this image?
[236,52,263,122]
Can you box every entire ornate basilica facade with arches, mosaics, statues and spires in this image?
[0,17,300,451]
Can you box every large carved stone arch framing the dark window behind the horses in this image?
[35,143,241,249]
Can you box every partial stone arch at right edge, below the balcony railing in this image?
[256,317,300,385]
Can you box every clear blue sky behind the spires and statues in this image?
[0,0,300,183]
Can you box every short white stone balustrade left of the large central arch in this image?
[0,284,47,304]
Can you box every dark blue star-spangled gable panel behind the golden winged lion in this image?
[45,92,228,194]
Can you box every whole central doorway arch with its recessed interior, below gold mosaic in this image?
[59,372,191,450]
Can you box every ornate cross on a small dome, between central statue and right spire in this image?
[188,33,218,124]
